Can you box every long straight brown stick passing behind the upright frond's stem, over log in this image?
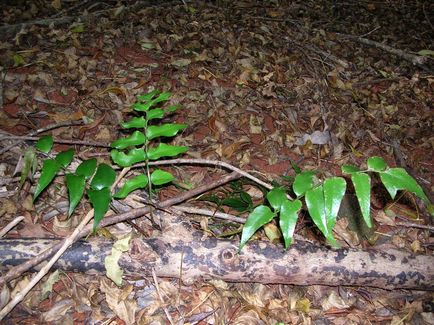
[0,172,241,286]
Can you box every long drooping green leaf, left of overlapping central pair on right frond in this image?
[305,185,338,246]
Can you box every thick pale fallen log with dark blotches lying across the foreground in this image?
[0,231,434,290]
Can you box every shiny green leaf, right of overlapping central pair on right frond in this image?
[323,177,347,231]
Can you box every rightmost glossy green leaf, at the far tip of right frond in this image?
[380,168,430,205]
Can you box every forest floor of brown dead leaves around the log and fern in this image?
[0,0,434,325]
